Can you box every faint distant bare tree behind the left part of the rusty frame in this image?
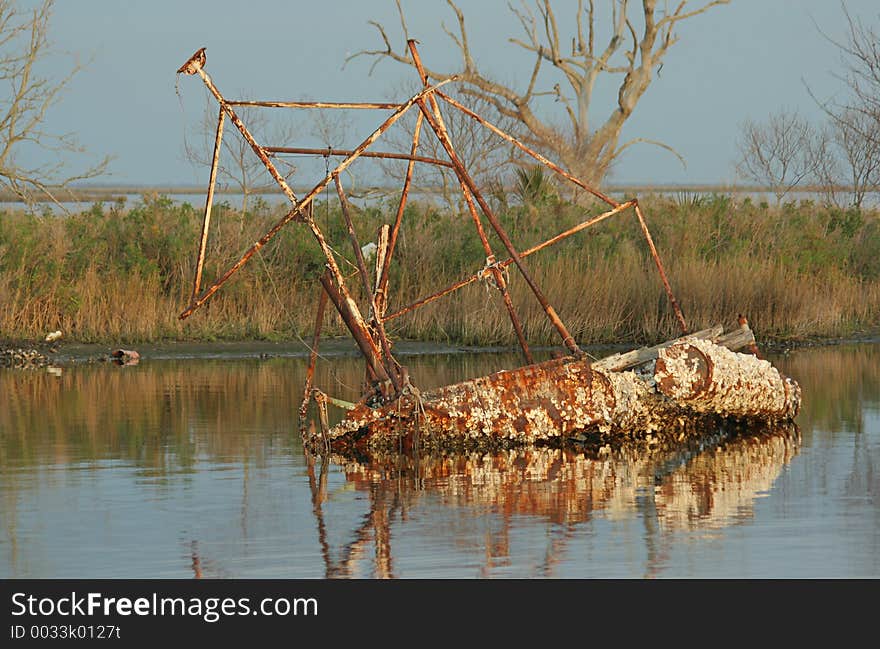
[183,97,296,213]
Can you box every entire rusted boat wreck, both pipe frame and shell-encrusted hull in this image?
[172,40,801,454]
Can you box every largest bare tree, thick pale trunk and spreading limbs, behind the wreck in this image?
[348,0,729,190]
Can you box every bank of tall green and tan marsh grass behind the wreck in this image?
[0,194,880,344]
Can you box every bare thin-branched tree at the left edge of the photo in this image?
[0,0,110,203]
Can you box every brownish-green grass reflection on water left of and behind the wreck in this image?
[0,354,515,473]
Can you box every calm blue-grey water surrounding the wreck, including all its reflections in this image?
[0,344,880,578]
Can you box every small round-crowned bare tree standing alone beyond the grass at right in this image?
[737,110,819,205]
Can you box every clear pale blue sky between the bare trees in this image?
[23,0,880,185]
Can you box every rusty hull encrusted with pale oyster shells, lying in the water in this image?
[330,336,800,453]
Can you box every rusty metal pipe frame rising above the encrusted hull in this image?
[179,40,687,426]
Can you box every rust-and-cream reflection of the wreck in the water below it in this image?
[308,424,801,578]
